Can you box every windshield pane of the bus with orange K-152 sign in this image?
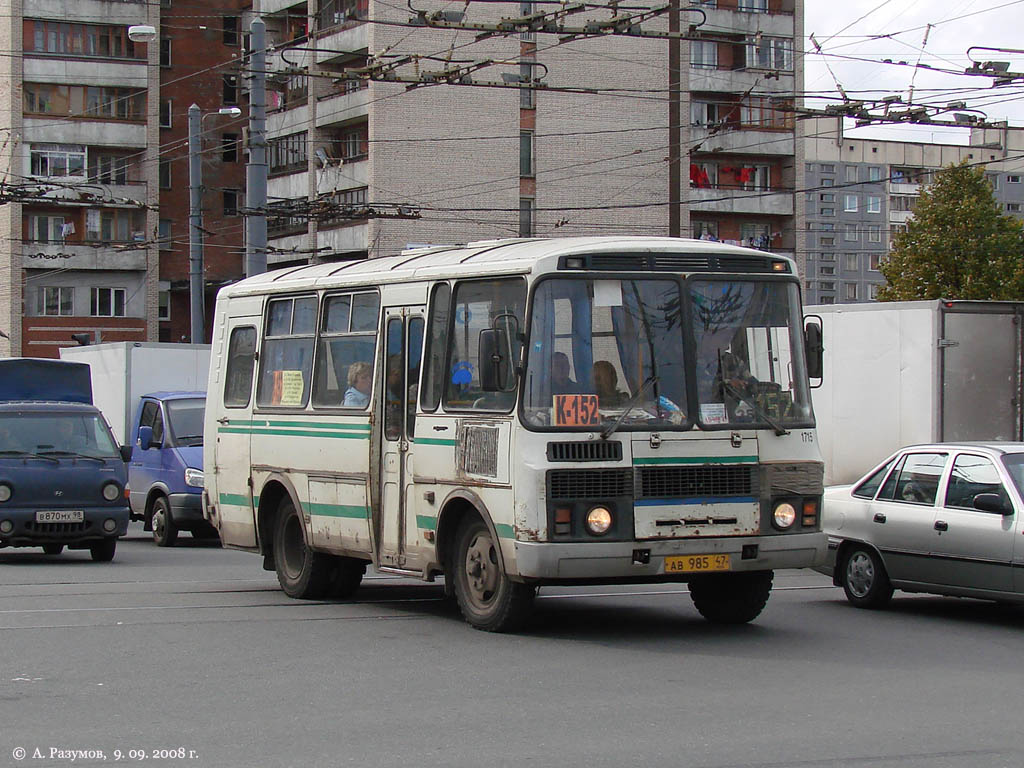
[523,278,687,429]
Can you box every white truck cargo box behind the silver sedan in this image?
[805,300,1024,484]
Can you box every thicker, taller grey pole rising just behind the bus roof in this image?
[246,18,267,278]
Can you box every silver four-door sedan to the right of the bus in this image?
[820,442,1024,608]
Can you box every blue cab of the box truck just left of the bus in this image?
[128,392,217,547]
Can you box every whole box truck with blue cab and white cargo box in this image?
[60,342,216,547]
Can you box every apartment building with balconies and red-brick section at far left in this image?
[0,0,248,357]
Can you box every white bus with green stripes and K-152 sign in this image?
[204,237,826,631]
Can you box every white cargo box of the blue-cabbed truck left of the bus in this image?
[60,341,210,444]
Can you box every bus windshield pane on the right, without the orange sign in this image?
[687,280,811,428]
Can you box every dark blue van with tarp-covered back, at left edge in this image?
[0,358,129,561]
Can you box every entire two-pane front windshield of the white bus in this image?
[522,278,811,430]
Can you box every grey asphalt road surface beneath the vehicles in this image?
[0,531,1024,768]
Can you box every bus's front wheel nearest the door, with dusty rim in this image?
[455,515,537,632]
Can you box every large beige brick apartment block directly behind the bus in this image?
[254,0,803,268]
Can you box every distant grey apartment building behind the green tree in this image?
[799,119,1024,304]
